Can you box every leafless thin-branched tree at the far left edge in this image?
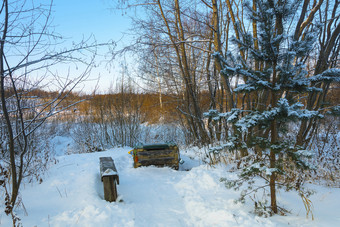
[0,0,114,225]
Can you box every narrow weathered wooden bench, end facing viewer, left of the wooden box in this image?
[99,157,119,202]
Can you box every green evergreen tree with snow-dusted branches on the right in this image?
[206,0,339,213]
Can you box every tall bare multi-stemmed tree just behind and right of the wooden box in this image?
[118,0,219,144]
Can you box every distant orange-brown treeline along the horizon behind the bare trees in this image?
[24,83,340,127]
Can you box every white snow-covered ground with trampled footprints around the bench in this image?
[0,141,340,227]
